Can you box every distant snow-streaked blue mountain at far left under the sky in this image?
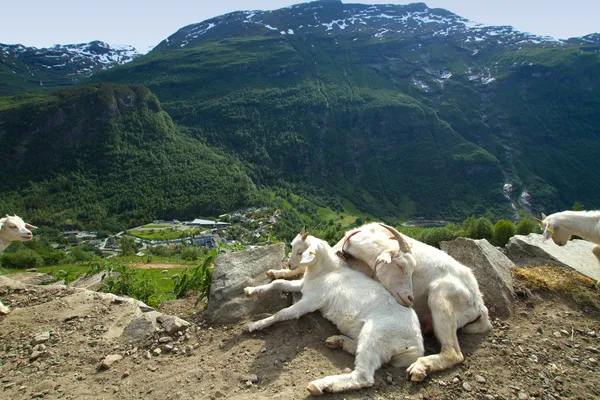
[0,40,140,95]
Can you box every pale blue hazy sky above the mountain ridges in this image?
[0,0,600,53]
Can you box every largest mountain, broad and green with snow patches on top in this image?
[0,1,600,227]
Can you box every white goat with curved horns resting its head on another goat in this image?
[267,223,492,381]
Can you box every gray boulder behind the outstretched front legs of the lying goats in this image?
[206,243,287,324]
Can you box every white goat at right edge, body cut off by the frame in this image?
[536,211,600,262]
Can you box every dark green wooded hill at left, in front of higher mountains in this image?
[0,84,256,230]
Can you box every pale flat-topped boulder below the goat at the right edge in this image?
[506,233,600,280]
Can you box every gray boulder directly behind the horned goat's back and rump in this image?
[440,238,515,317]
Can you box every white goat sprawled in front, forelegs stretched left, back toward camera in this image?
[244,232,423,396]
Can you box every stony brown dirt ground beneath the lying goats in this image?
[0,278,600,400]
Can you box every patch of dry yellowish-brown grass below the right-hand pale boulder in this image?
[513,265,600,310]
